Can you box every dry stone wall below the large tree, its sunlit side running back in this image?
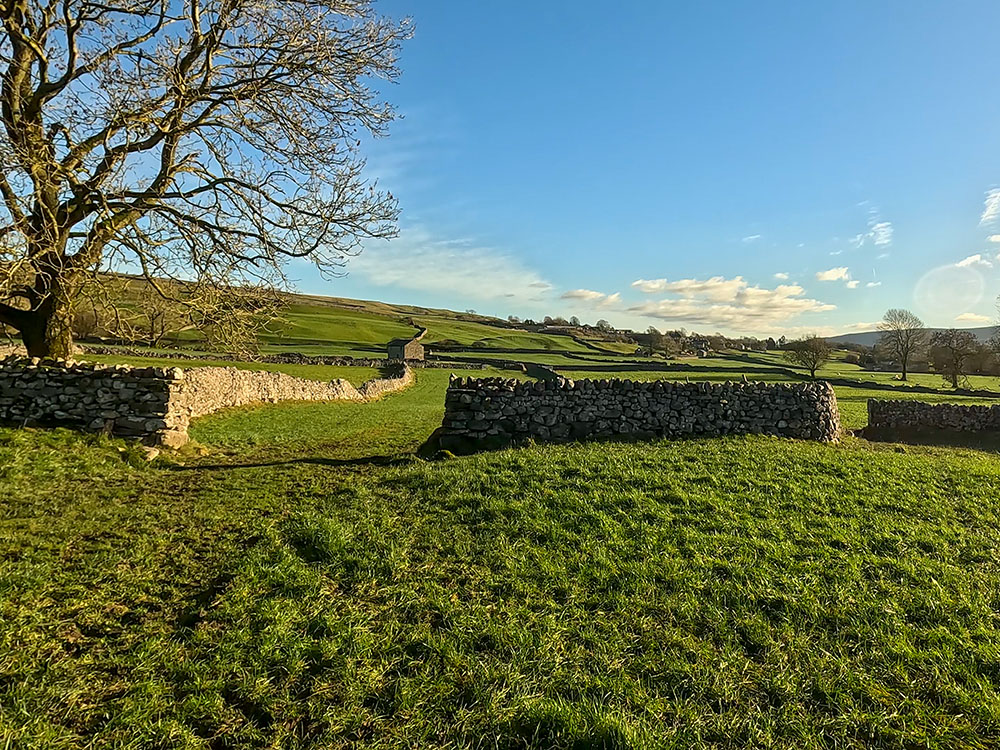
[0,357,413,446]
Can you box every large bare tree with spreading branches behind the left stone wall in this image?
[0,0,409,356]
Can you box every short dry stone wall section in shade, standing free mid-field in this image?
[437,378,840,450]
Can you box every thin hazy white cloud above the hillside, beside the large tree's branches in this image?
[348,226,552,301]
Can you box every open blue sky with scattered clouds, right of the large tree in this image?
[298,0,1000,335]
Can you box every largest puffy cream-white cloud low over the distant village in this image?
[628,276,836,332]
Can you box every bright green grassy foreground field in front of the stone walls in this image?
[0,432,1000,749]
